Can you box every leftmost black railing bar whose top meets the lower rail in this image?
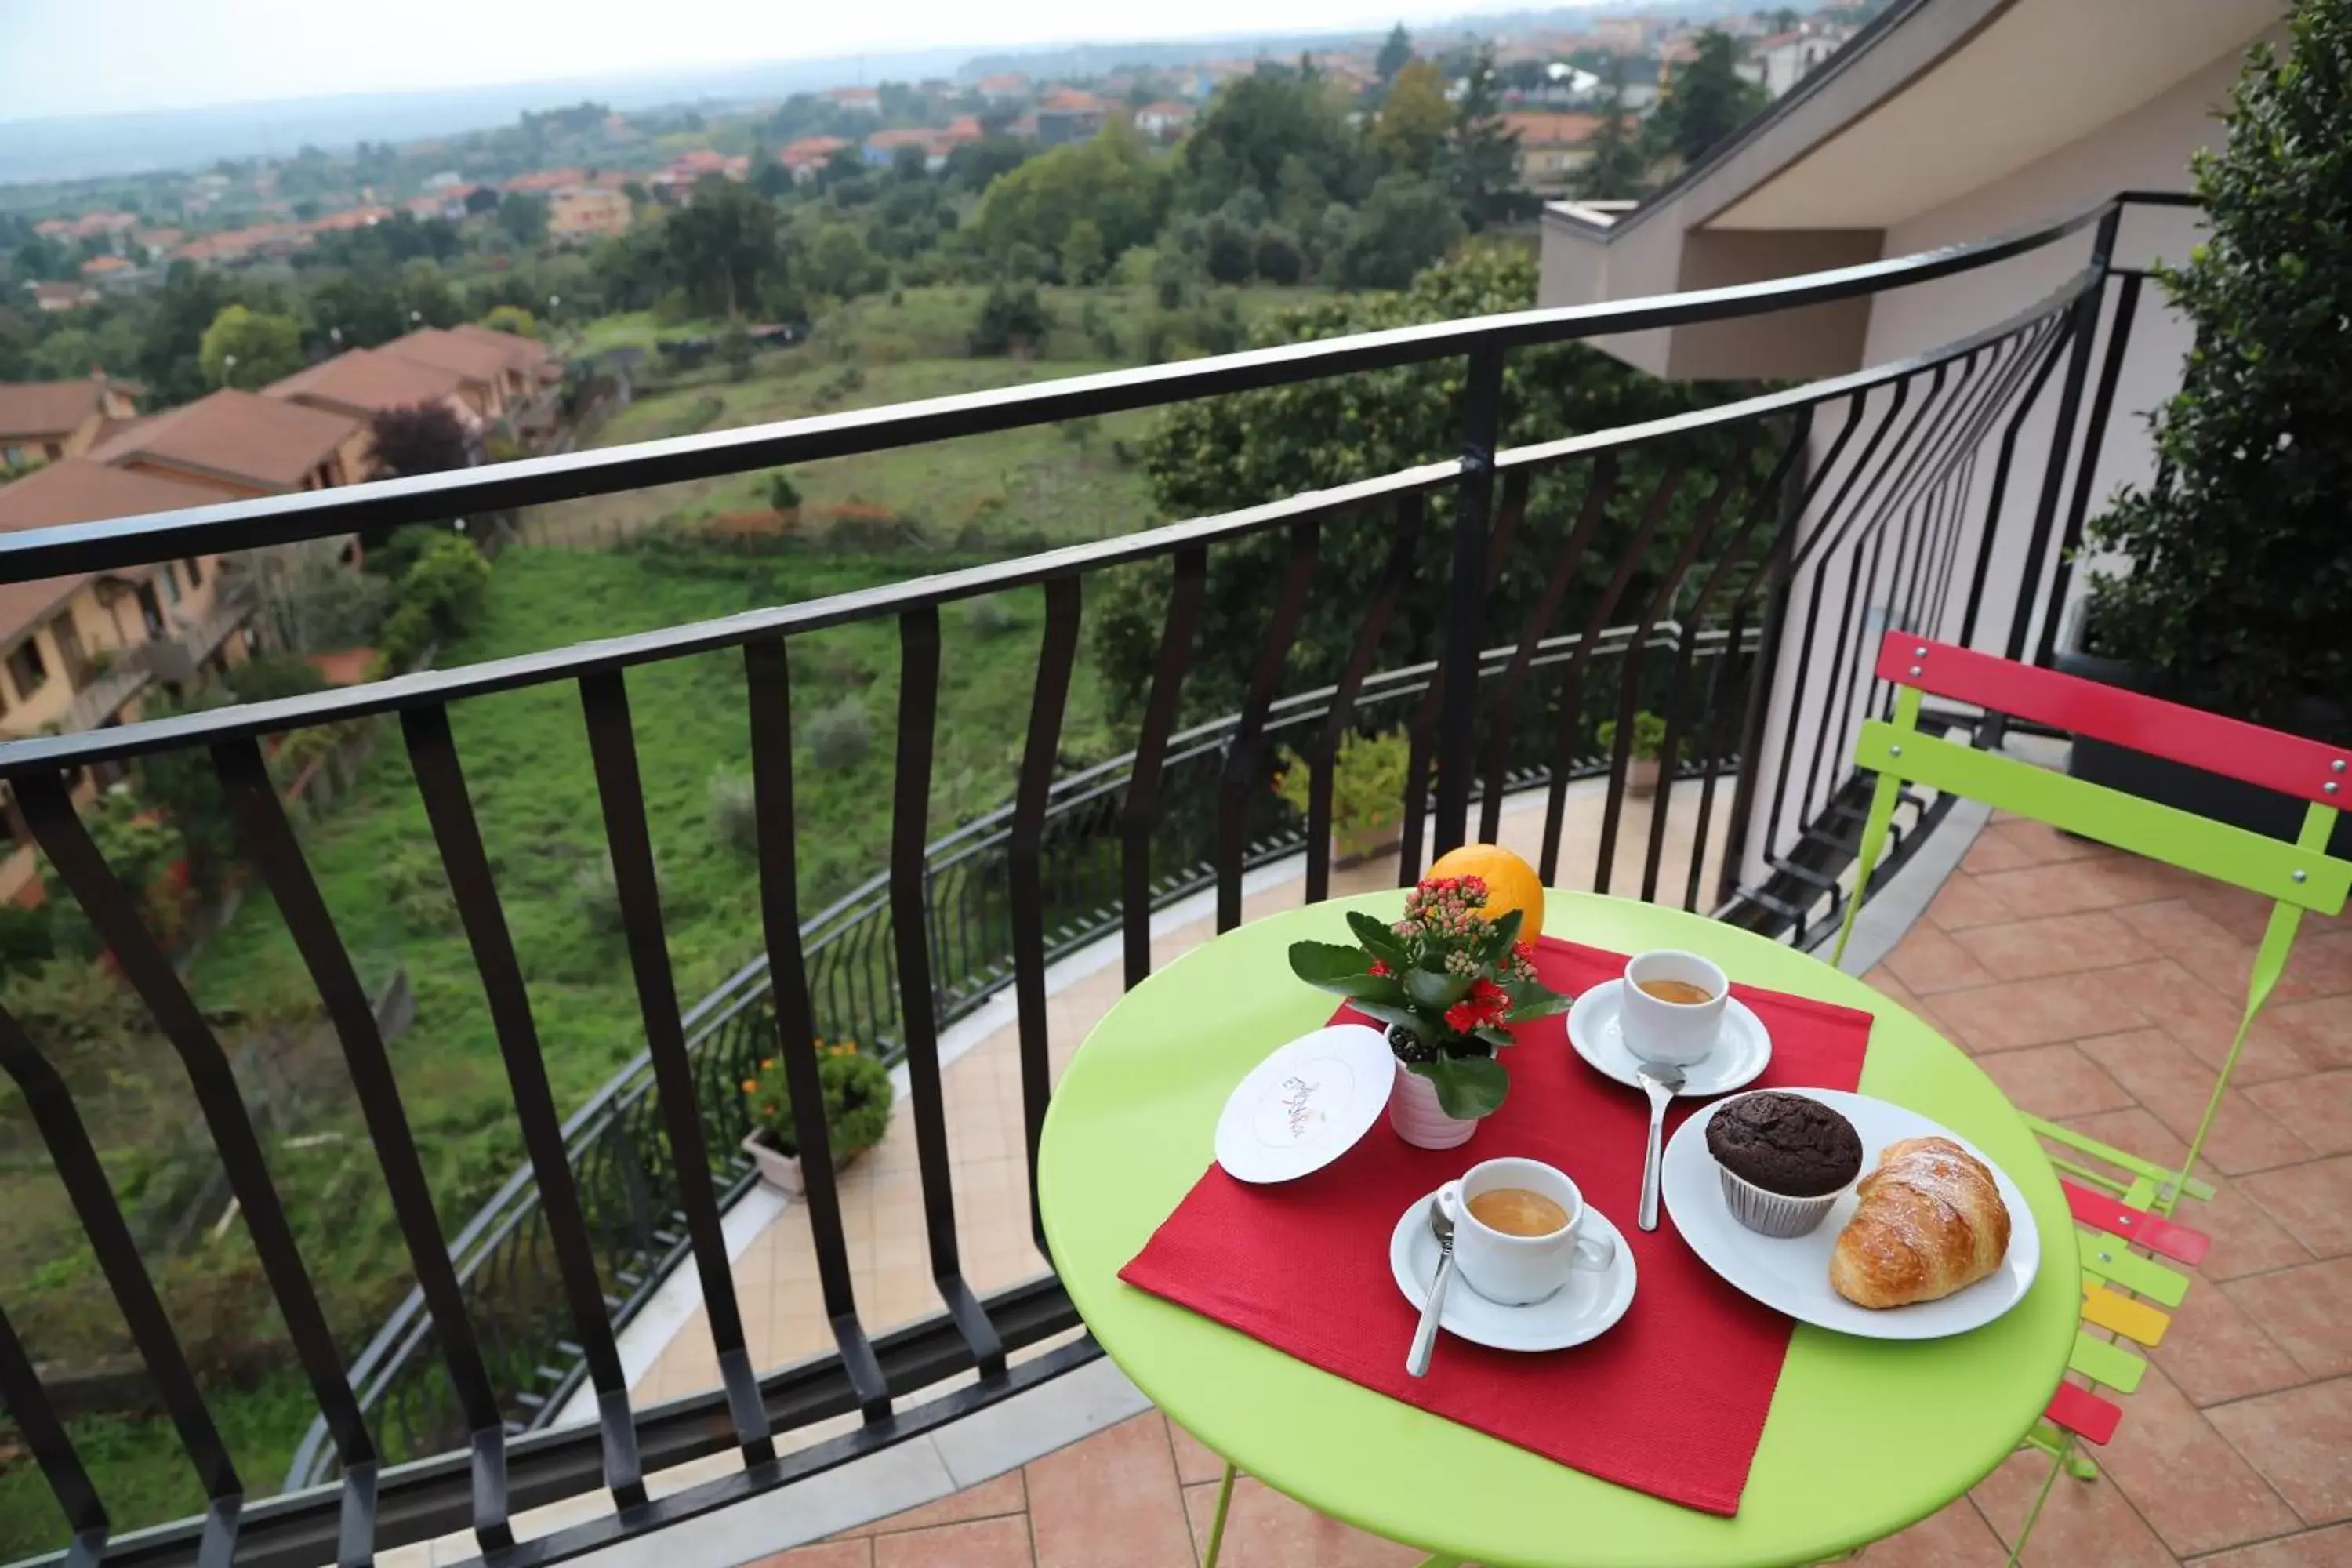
[9,774,376,1472]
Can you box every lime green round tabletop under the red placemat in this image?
[1040,893,2082,1568]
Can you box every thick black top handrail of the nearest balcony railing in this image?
[0,195,2129,583]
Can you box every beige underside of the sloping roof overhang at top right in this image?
[1705,0,2286,230]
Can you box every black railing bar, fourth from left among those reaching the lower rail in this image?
[579,670,771,1465]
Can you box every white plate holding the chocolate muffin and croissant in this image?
[1661,1088,2042,1340]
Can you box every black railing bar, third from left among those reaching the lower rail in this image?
[400,706,644,1507]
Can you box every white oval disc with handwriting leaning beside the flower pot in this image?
[1216,1022,1397,1182]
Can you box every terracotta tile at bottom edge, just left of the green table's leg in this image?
[1028,1410,1192,1568]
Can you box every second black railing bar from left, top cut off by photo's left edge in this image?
[0,1008,245,1500]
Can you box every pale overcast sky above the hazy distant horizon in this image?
[0,0,1451,120]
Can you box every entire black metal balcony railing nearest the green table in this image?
[0,190,2164,1568]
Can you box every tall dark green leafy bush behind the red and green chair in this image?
[2089,0,2352,739]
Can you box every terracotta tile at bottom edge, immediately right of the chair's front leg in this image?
[2060,1370,2300,1556]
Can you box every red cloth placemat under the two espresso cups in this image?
[1120,938,1870,1514]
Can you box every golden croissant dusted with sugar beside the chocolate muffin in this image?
[1830,1138,2009,1307]
